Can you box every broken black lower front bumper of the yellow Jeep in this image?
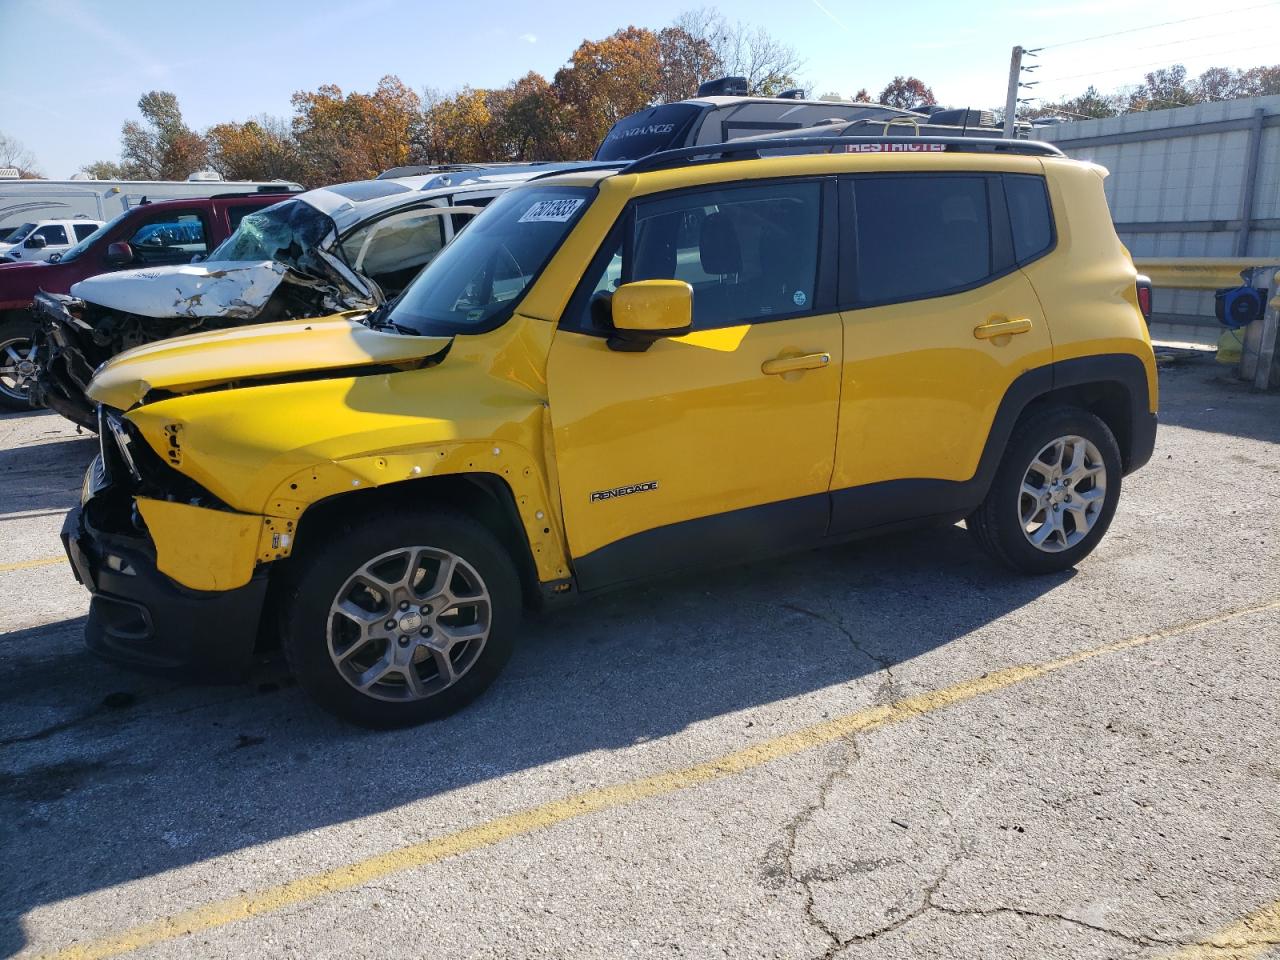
[63,483,268,682]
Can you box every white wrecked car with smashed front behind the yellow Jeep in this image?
[32,164,573,428]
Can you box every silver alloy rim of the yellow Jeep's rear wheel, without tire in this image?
[1018,435,1107,553]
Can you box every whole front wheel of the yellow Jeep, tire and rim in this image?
[283,509,521,728]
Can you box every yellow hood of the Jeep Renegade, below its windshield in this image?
[88,314,452,410]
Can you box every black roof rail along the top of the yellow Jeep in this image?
[620,136,1065,173]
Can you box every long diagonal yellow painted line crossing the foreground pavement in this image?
[30,599,1280,960]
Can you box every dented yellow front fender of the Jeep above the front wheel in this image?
[128,316,570,581]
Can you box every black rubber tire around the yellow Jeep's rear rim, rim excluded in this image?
[965,406,1121,573]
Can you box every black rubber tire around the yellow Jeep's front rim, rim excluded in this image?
[280,509,521,730]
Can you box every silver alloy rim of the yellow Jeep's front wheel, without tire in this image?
[328,547,493,701]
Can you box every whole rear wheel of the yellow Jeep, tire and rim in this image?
[965,407,1121,573]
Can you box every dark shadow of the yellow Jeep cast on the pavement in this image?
[0,527,1070,955]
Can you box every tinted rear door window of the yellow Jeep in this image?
[852,174,992,305]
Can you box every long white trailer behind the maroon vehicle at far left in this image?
[0,172,302,235]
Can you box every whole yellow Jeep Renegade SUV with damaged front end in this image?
[64,133,1156,726]
